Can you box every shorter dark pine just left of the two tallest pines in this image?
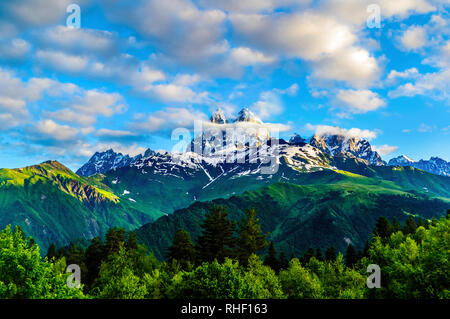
[168,229,195,270]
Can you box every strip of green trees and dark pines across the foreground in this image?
[0,206,450,299]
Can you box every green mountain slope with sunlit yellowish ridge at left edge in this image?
[0,161,153,251]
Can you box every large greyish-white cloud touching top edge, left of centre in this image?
[106,0,228,63]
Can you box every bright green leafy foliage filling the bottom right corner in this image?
[363,218,450,299]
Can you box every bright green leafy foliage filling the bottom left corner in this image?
[0,226,84,299]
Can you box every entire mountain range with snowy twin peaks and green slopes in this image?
[0,109,450,258]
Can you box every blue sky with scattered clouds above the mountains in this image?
[0,0,450,169]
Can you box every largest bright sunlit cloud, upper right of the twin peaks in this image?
[230,11,379,86]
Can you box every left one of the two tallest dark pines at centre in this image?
[197,206,236,262]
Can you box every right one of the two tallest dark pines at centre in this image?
[236,208,269,266]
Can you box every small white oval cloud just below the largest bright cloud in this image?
[336,90,386,113]
